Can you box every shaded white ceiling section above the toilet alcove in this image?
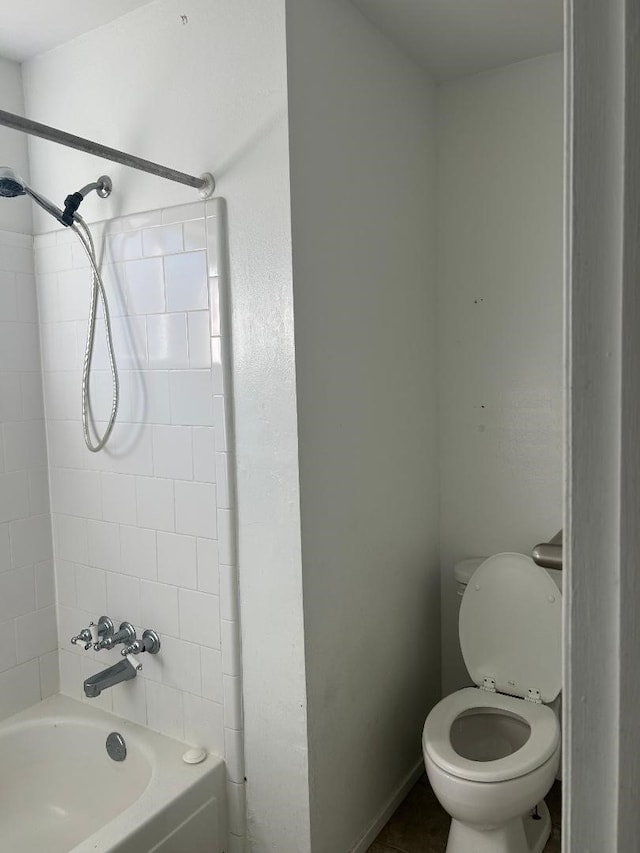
[352,0,563,81]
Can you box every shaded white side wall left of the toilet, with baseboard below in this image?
[287,0,440,853]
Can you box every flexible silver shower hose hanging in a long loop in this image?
[71,213,120,453]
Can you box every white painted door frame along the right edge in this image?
[562,0,628,853]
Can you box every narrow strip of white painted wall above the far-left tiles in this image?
[0,57,33,234]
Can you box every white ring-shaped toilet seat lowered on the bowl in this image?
[422,687,560,782]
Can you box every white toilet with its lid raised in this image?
[422,554,562,853]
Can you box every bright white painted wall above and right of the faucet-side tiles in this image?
[25,0,309,853]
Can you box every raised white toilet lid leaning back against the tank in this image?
[460,554,562,703]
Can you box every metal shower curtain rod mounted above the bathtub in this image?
[0,110,215,199]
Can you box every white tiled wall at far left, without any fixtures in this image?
[0,231,58,718]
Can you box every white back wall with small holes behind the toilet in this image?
[437,54,563,693]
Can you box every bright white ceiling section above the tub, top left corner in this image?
[0,0,154,62]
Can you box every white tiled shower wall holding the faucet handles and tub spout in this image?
[35,200,244,850]
